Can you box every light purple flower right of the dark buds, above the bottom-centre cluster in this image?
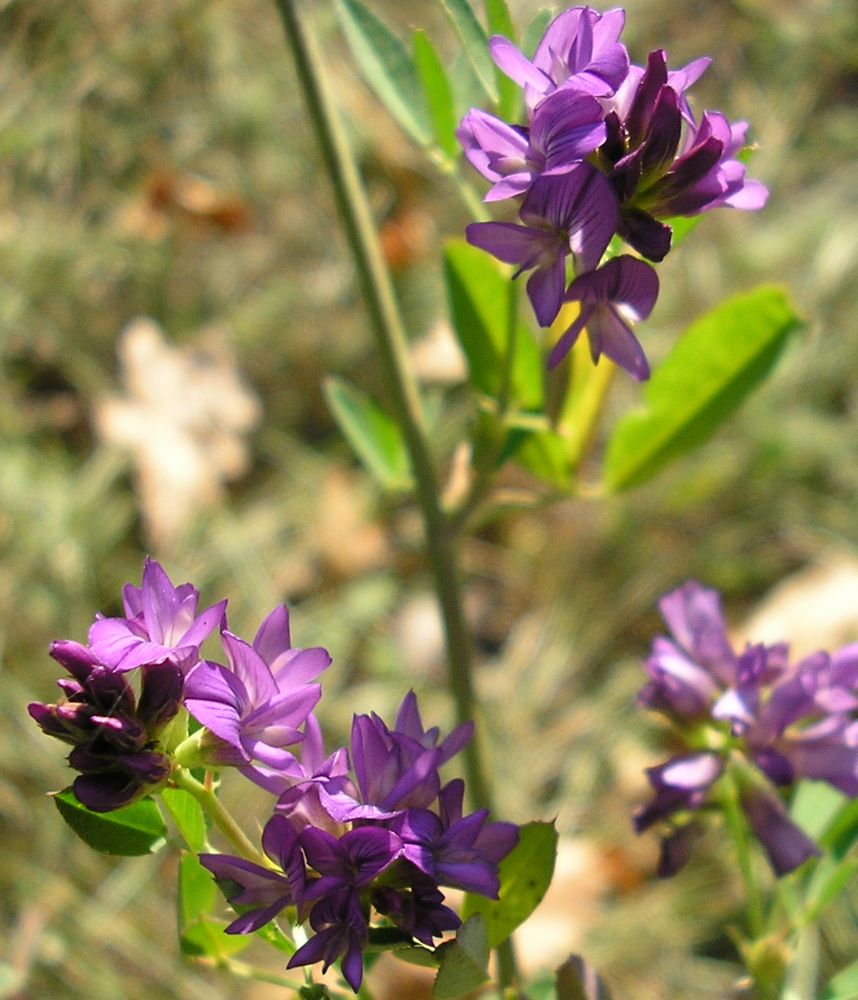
[185,606,331,768]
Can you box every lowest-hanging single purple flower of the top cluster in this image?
[548,255,658,380]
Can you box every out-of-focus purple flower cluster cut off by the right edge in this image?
[634,581,858,875]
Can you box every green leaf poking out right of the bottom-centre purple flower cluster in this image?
[462,823,557,948]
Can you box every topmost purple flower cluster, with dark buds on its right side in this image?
[457,7,768,379]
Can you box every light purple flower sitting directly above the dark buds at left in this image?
[89,559,226,671]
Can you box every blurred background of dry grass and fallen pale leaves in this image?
[0,0,858,1000]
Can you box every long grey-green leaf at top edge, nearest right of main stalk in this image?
[337,0,432,146]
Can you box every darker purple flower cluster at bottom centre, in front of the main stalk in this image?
[200,692,518,991]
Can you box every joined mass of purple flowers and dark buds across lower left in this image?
[29,560,518,991]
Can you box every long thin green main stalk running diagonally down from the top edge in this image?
[275,0,516,984]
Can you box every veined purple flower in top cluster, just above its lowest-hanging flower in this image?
[466,163,618,326]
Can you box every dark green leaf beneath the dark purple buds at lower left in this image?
[53,788,167,857]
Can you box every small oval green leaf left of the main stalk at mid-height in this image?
[324,376,411,490]
